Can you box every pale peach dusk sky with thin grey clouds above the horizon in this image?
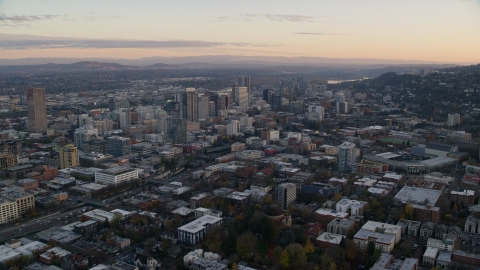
[0,0,480,64]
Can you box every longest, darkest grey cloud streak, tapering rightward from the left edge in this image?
[0,34,283,50]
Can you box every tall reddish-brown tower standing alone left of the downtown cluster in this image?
[25,88,47,132]
